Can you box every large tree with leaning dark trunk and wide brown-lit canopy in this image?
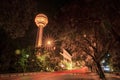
[54,0,119,80]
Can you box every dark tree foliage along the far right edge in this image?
[100,0,120,71]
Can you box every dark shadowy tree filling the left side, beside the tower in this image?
[0,0,37,73]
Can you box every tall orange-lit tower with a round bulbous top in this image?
[35,14,48,54]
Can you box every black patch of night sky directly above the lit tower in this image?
[36,0,71,16]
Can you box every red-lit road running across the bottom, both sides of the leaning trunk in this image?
[0,70,120,80]
